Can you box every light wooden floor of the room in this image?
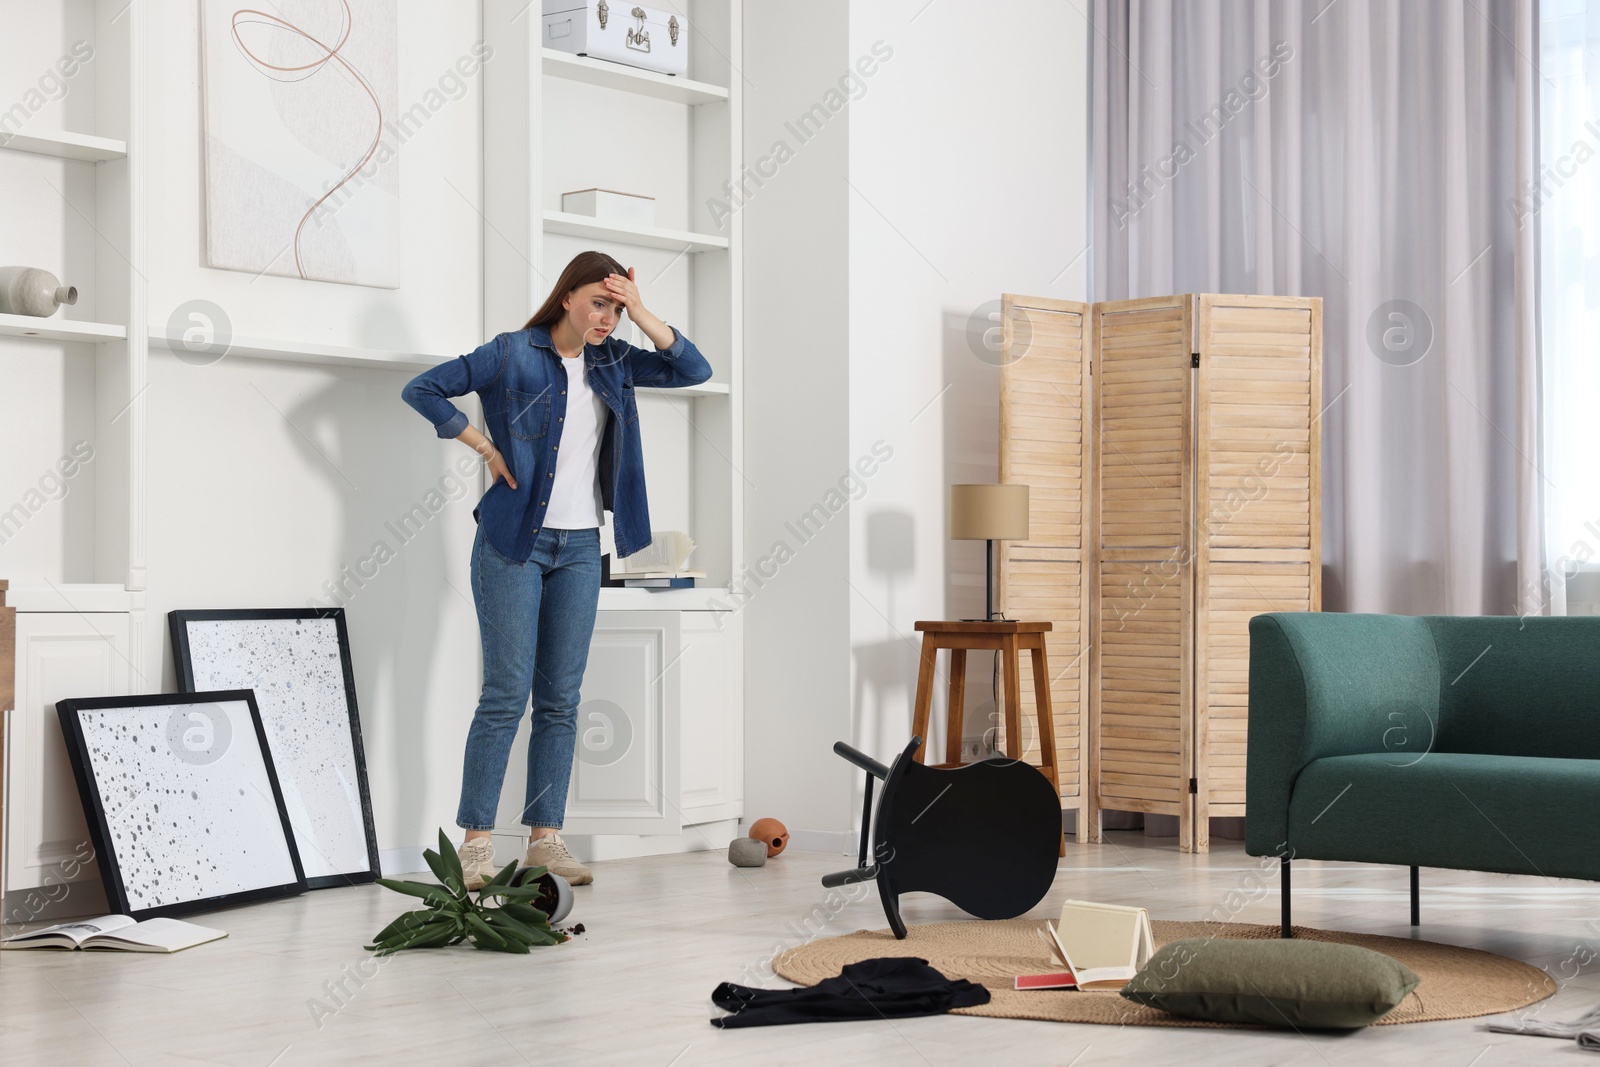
[0,832,1600,1067]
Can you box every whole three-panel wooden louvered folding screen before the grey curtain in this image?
[1000,294,1322,851]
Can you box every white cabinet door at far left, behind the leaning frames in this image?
[5,611,133,895]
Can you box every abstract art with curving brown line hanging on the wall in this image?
[200,0,400,290]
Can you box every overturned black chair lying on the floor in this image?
[822,736,1061,937]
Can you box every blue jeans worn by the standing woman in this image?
[456,525,600,830]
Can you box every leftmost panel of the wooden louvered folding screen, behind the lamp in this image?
[997,296,1099,841]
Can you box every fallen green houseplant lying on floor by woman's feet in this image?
[363,830,571,955]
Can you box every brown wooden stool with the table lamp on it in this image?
[910,619,1067,856]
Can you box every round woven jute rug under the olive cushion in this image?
[773,918,1555,1027]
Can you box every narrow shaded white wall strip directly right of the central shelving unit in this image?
[734,0,851,848]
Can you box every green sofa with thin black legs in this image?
[1245,611,1600,937]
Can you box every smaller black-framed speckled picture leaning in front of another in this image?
[56,689,306,920]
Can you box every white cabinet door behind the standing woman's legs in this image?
[496,611,683,835]
